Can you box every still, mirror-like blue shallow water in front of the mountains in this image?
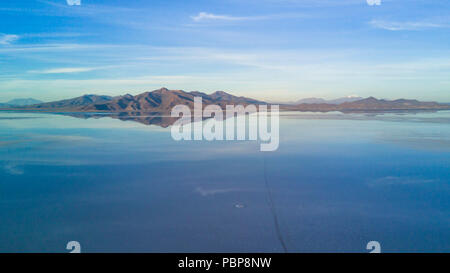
[0,111,450,252]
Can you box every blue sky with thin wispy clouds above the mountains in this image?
[0,0,450,102]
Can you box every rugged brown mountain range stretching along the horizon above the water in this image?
[0,88,450,114]
